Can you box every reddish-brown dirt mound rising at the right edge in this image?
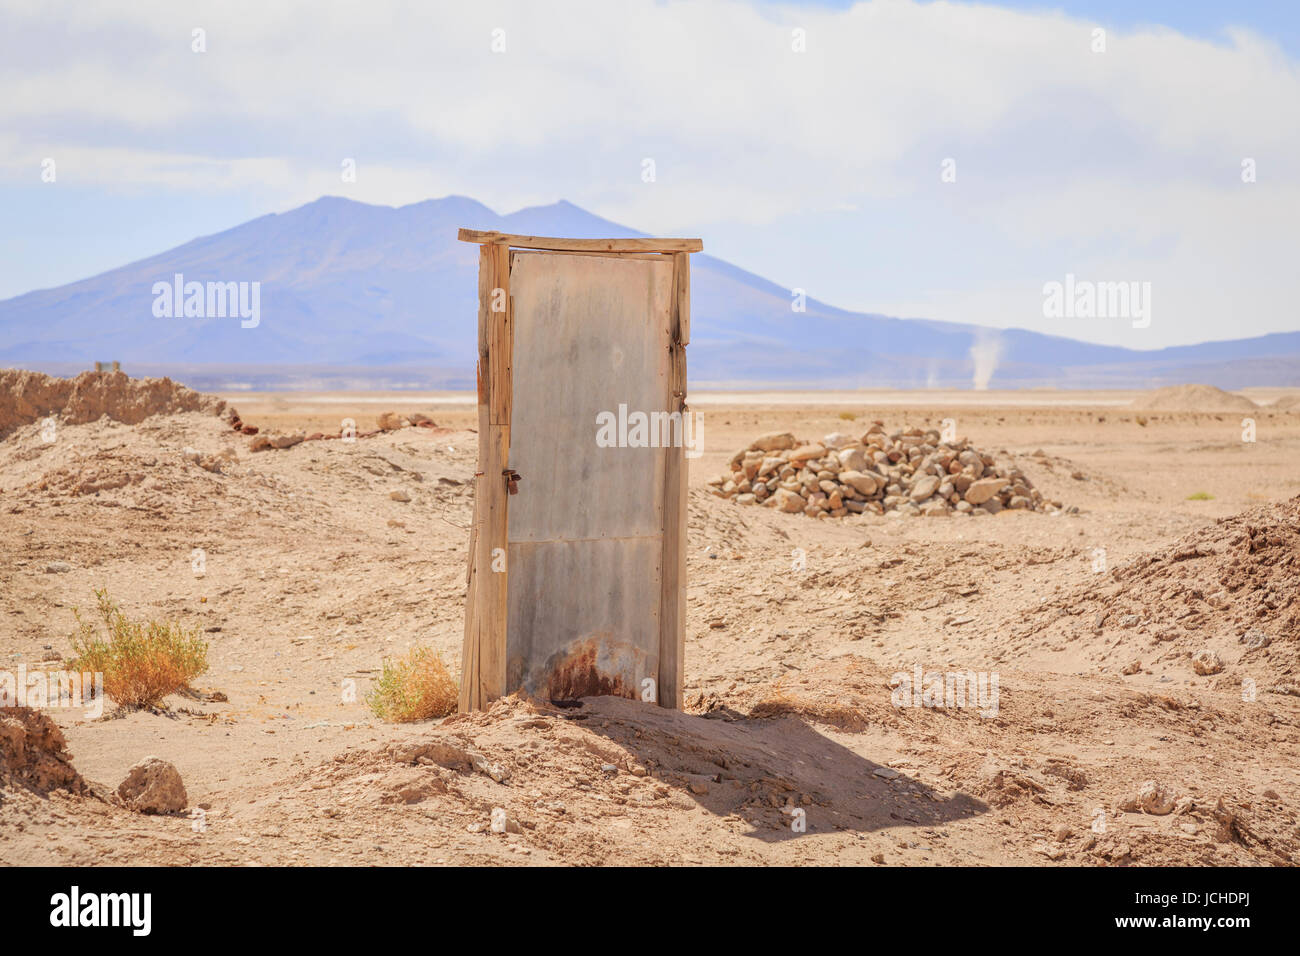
[1013,497,1300,695]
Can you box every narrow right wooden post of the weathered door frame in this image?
[658,252,690,710]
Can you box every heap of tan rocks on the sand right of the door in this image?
[709,421,1062,518]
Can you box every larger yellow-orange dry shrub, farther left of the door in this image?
[72,589,208,708]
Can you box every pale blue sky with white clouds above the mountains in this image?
[0,0,1300,349]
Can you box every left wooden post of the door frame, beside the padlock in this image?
[459,242,515,711]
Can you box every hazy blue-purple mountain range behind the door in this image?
[0,196,1300,389]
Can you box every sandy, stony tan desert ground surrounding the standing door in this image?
[0,390,1300,865]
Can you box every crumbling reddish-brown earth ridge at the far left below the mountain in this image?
[0,368,234,437]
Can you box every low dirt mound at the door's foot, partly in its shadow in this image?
[233,695,982,865]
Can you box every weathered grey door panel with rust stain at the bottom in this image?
[506,252,673,696]
